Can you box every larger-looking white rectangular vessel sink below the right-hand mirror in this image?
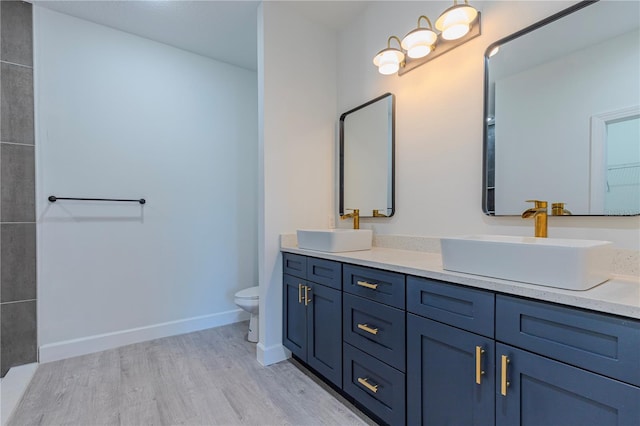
[440,235,613,290]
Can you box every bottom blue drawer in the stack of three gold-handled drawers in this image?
[343,343,405,425]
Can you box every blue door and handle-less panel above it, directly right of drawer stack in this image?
[407,276,495,425]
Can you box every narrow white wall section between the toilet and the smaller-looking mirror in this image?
[258,1,338,364]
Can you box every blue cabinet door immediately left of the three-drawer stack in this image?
[307,283,342,388]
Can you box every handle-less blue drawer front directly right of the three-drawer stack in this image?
[407,276,495,338]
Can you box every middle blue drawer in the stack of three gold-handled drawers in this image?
[342,293,405,371]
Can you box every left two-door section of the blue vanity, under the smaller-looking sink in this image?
[282,253,342,388]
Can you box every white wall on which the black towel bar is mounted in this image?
[34,7,258,358]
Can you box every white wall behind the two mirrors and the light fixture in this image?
[336,1,640,250]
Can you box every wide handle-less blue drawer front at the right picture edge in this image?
[496,295,640,386]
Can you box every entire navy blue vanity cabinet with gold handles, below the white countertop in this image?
[283,253,640,426]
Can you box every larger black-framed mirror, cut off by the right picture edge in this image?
[483,1,640,216]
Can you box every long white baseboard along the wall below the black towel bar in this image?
[39,309,249,363]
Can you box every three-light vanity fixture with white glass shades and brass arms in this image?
[373,0,480,75]
